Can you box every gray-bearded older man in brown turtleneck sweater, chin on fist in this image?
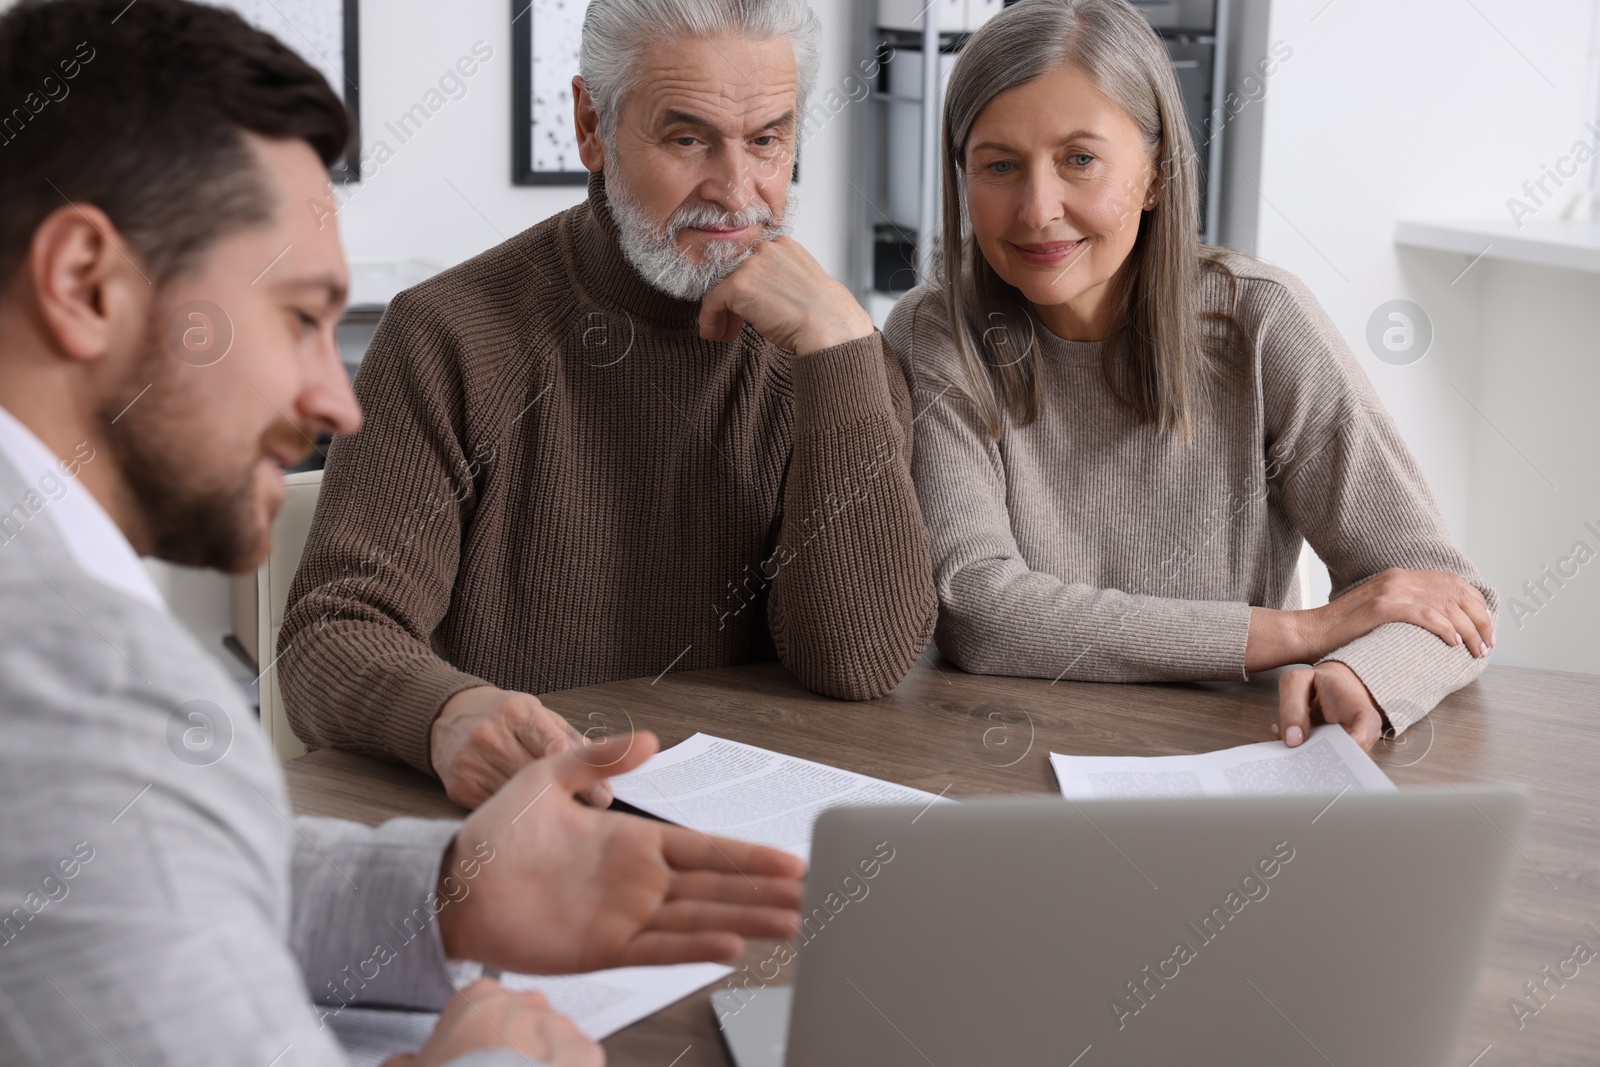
[277,0,936,805]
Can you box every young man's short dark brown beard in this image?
[99,310,267,573]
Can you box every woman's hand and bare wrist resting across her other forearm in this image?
[1245,568,1494,670]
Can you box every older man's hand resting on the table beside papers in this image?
[430,685,611,808]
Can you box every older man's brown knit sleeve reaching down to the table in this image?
[275,294,486,774]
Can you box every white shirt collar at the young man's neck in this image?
[0,406,166,611]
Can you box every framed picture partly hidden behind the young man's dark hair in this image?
[210,0,362,182]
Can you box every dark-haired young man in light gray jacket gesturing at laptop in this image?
[0,0,800,1067]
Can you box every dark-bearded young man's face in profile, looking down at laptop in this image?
[112,136,362,573]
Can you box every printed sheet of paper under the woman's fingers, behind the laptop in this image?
[1050,725,1395,800]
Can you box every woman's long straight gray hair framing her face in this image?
[939,0,1230,437]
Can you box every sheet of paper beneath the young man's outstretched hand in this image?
[328,963,733,1067]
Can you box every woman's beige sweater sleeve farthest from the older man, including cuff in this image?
[1259,275,1499,733]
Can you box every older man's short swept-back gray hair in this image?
[578,0,821,144]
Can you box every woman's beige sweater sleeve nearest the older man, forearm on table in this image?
[885,291,1250,681]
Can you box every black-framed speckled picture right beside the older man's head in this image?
[510,0,589,186]
